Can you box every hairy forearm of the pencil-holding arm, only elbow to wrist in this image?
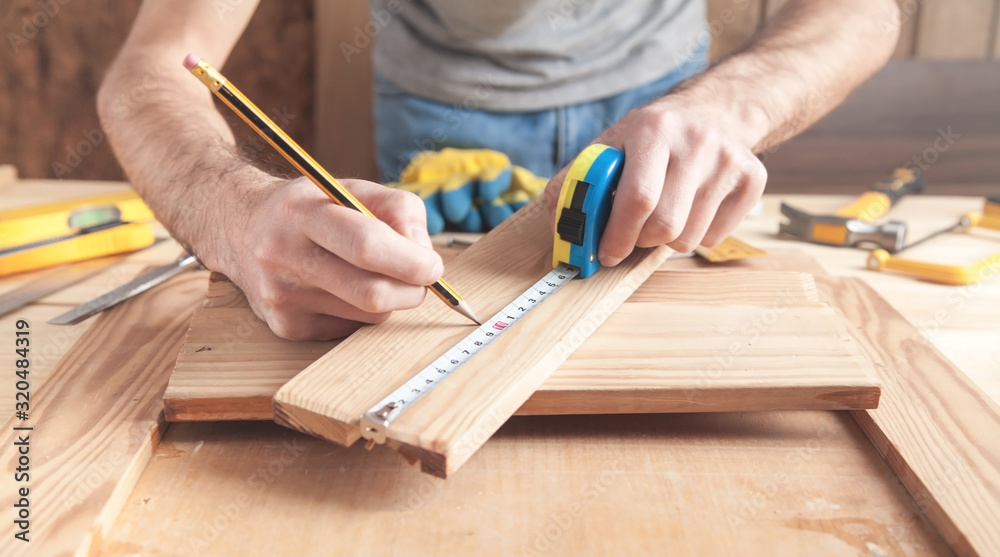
[98,53,272,268]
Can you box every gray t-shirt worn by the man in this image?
[369,0,708,112]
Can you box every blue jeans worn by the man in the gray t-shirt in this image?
[375,46,708,182]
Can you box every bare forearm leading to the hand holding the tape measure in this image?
[674,0,898,153]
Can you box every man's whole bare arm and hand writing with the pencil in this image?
[98,0,443,340]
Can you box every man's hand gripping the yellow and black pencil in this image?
[208,178,444,340]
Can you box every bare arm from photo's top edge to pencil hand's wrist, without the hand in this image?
[97,0,264,270]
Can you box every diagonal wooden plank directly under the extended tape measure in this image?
[274,198,670,477]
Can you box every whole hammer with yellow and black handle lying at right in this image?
[779,168,924,253]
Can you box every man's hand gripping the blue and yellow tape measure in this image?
[545,94,767,266]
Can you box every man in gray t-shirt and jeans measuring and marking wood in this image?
[98,0,897,339]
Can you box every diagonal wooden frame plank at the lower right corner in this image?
[820,279,1000,555]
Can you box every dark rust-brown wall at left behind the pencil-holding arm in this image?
[0,0,315,180]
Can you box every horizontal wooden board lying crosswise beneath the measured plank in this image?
[164,264,878,421]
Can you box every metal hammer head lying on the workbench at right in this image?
[779,203,906,253]
